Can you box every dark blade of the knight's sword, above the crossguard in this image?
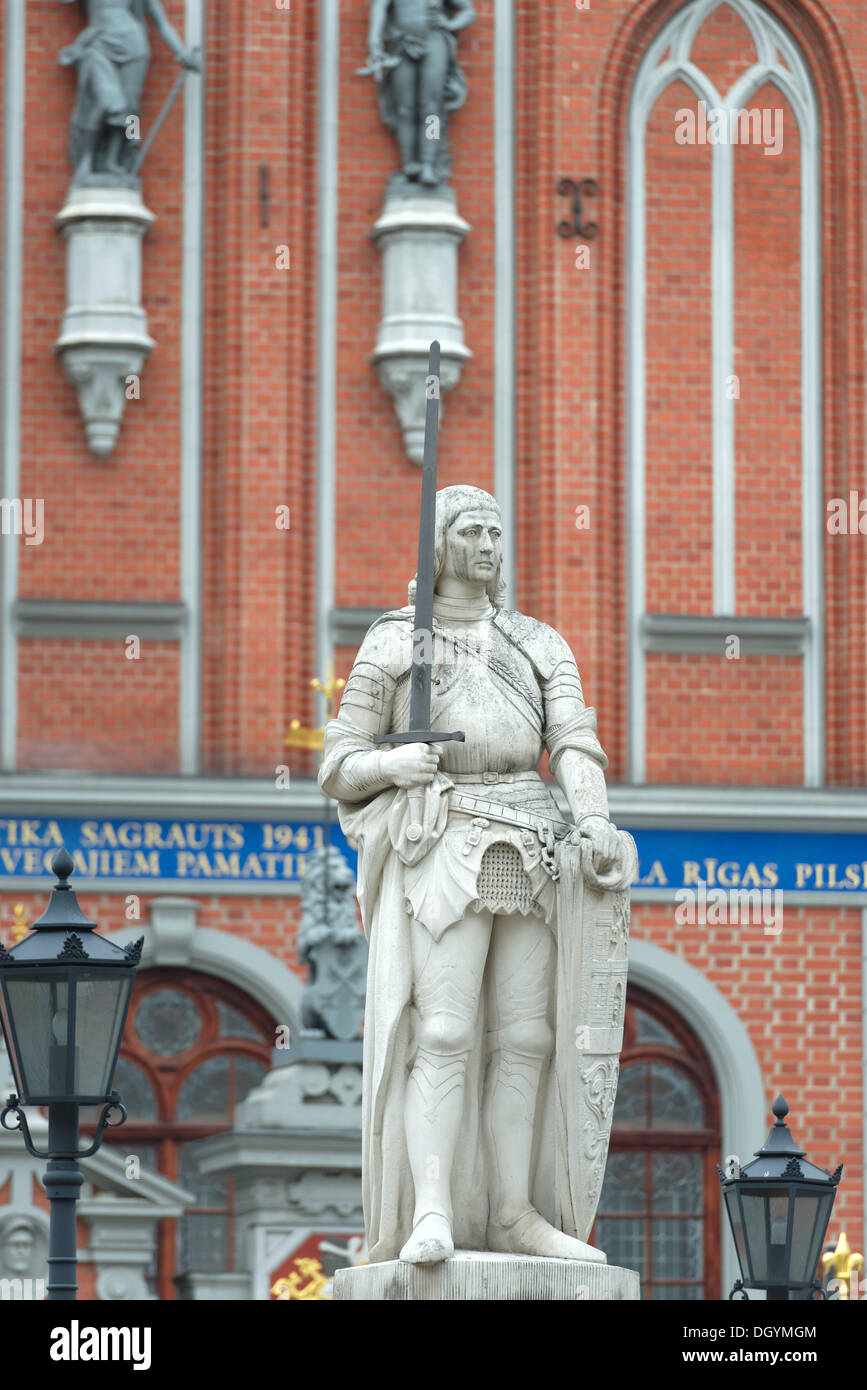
[410,339,439,733]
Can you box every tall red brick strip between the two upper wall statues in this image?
[203,0,324,776]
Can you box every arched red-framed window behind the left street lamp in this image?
[82,969,274,1300]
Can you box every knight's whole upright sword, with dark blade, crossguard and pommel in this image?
[374,339,464,842]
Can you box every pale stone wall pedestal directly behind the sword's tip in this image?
[371,189,472,463]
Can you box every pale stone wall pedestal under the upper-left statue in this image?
[54,183,154,456]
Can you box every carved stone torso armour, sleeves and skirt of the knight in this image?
[321,595,607,938]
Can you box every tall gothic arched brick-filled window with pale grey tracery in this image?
[625,0,825,785]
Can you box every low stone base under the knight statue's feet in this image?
[333,1250,639,1302]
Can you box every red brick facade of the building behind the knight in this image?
[0,0,867,1295]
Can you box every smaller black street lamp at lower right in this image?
[717,1095,843,1300]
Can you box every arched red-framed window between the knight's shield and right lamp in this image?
[592,987,721,1300]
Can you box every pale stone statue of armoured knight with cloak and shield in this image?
[318,487,636,1264]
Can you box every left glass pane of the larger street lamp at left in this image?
[0,974,68,1102]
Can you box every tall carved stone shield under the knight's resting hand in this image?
[557,831,635,1240]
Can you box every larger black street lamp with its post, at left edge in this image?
[0,849,145,1300]
